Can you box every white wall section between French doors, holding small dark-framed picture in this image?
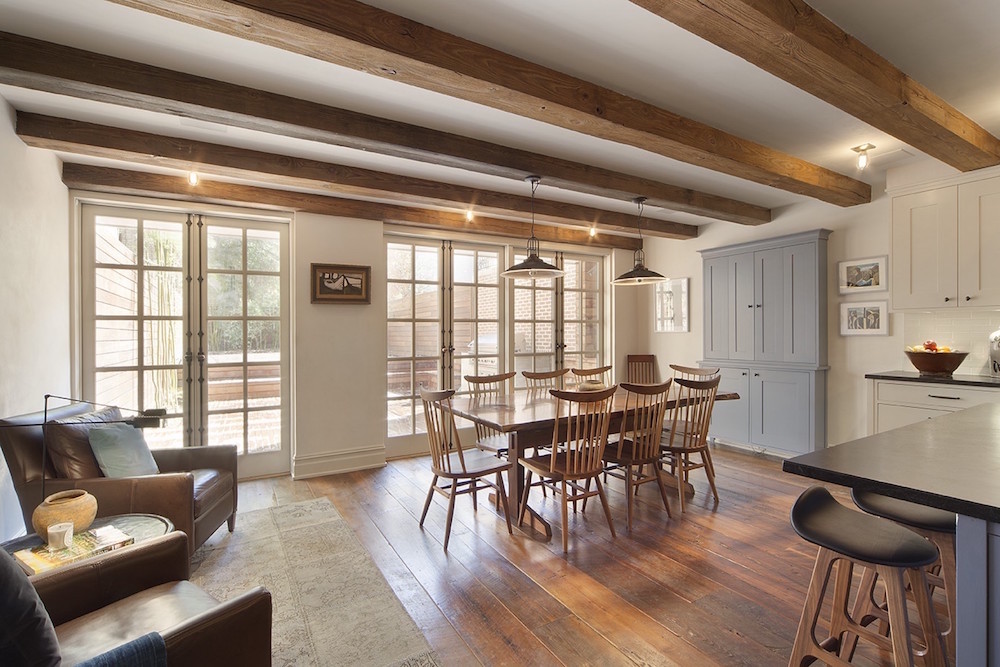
[292,214,386,477]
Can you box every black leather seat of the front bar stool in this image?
[791,486,938,568]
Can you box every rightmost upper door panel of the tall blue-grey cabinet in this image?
[782,243,820,363]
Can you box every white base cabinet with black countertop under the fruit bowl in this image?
[867,371,1000,434]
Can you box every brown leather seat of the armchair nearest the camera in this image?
[56,581,219,665]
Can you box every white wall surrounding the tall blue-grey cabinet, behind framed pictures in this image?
[628,184,905,444]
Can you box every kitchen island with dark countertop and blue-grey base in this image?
[782,403,1000,667]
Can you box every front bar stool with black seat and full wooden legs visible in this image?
[788,486,946,667]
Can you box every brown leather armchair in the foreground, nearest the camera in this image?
[29,531,271,667]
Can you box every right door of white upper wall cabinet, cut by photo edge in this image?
[958,178,1000,307]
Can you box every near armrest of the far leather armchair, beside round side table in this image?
[45,472,194,552]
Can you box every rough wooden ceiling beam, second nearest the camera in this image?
[107,0,871,206]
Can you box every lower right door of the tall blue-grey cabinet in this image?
[750,369,813,452]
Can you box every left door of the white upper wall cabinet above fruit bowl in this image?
[890,186,958,308]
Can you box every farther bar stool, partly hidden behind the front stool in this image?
[851,489,957,656]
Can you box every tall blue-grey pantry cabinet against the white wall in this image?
[701,229,830,454]
